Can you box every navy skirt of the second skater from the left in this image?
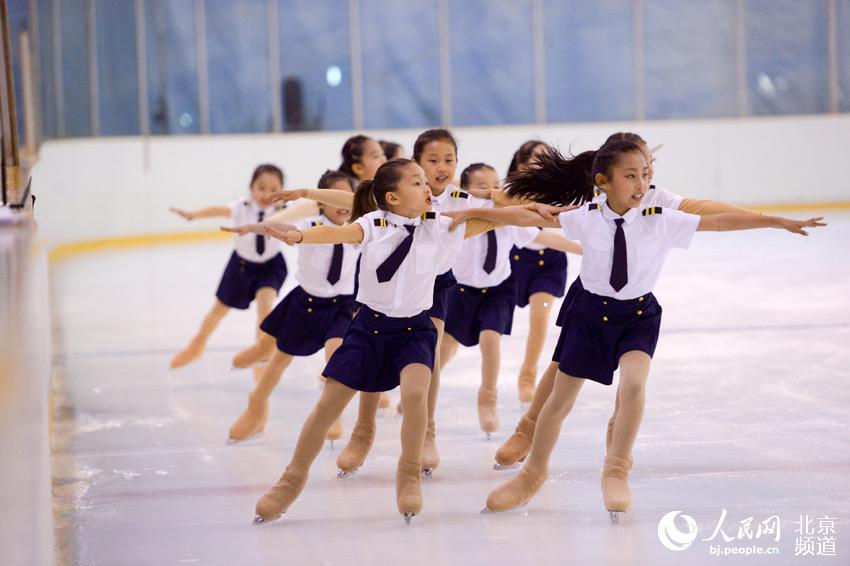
[260,286,354,356]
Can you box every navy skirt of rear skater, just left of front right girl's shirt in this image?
[511,246,567,308]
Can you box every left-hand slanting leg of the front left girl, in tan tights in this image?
[255,379,357,523]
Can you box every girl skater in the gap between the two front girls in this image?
[440,163,581,438]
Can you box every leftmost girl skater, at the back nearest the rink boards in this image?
[171,164,286,369]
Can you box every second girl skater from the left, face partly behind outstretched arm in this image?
[223,171,360,443]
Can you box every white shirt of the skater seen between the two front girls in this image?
[452,197,540,289]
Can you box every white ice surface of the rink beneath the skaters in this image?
[51,212,850,566]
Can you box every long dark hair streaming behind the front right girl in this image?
[505,140,642,205]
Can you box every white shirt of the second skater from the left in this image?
[294,215,360,298]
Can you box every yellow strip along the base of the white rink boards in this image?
[47,201,850,262]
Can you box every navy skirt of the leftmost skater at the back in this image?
[215,252,286,310]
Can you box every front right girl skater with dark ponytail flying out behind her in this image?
[448,140,825,522]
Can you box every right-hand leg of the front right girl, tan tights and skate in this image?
[602,351,652,513]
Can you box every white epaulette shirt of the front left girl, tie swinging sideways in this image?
[355,210,464,318]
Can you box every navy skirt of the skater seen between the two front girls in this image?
[446,275,516,346]
